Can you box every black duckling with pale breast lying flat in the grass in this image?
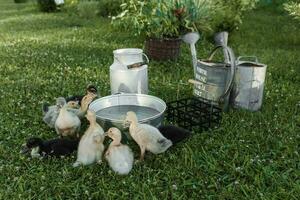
[22,137,79,158]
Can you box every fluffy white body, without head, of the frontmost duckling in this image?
[106,145,133,175]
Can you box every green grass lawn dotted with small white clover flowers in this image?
[0,0,300,199]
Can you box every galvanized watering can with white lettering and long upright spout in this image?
[183,32,235,111]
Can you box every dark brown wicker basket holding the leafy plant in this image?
[145,38,181,60]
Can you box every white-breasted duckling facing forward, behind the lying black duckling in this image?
[55,97,81,137]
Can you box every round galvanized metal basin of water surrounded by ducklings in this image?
[89,93,167,131]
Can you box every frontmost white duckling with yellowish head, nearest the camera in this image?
[105,127,133,175]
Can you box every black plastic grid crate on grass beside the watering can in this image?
[166,97,222,131]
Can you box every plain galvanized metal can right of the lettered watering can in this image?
[231,56,267,111]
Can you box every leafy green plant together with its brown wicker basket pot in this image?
[113,0,211,60]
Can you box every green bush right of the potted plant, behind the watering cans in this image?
[213,0,258,32]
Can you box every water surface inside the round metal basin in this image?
[96,105,160,120]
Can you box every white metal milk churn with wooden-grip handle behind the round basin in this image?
[110,48,149,94]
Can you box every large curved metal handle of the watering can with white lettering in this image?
[208,45,235,102]
